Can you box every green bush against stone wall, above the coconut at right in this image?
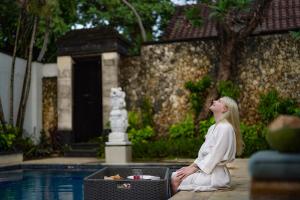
[258,89,299,124]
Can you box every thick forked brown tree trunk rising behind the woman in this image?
[195,0,272,133]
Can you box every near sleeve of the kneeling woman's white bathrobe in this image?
[196,123,235,174]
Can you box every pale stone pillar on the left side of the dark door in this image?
[57,56,73,144]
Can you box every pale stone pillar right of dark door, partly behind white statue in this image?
[101,52,120,126]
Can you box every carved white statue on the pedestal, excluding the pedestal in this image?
[108,87,129,144]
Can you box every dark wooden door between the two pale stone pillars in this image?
[73,58,102,142]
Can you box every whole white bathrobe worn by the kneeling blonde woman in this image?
[172,122,236,191]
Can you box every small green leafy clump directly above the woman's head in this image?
[217,81,240,99]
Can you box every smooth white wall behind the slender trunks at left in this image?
[0,53,57,142]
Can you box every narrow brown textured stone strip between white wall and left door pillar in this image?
[43,77,57,136]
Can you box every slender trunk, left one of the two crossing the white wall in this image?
[9,9,23,125]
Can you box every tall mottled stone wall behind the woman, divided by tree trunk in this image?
[120,34,300,133]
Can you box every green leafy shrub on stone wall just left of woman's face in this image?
[184,76,212,116]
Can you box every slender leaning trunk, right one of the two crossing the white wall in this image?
[17,16,38,130]
